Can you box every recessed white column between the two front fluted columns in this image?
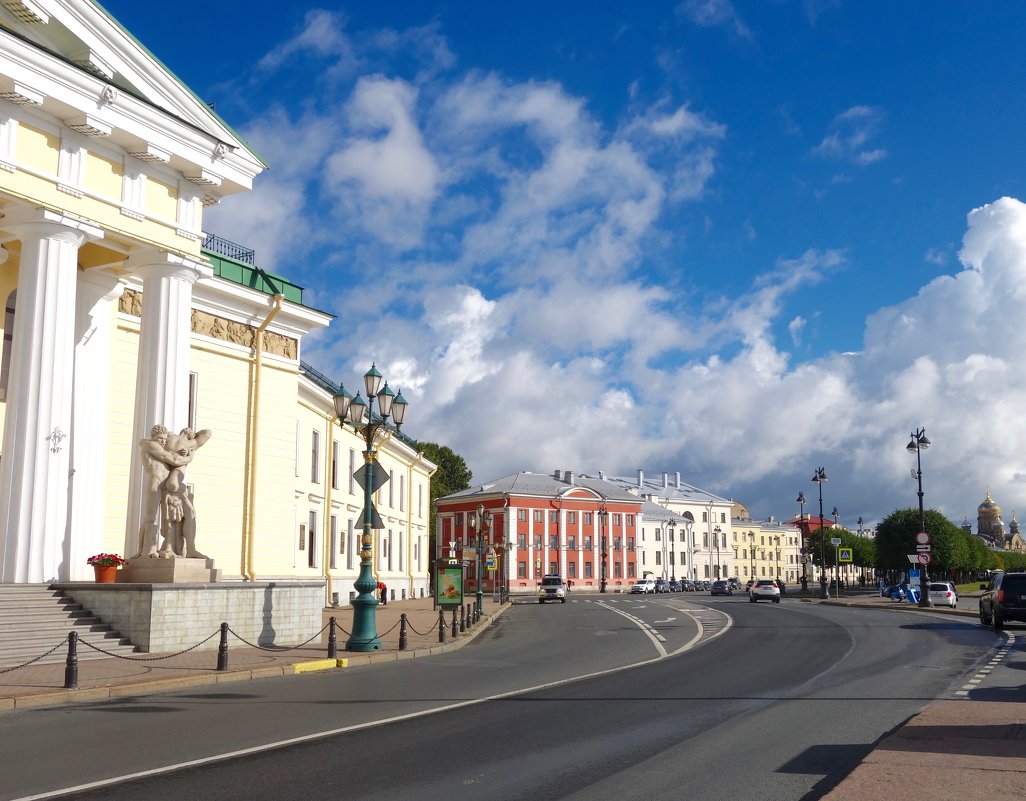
[62,271,124,580]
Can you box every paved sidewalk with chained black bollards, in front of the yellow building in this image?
[0,595,509,711]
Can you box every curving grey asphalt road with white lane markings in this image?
[0,594,1003,801]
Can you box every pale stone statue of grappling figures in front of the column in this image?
[131,424,212,559]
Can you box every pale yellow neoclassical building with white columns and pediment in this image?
[0,0,434,603]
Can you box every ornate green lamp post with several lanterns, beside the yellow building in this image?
[334,364,407,651]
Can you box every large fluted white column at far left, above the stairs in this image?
[0,211,101,584]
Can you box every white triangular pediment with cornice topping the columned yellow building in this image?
[0,0,266,196]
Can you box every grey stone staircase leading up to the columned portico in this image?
[0,585,135,670]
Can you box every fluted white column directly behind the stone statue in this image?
[125,251,211,556]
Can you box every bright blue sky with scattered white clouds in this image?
[105,0,1026,526]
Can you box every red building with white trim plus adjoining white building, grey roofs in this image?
[435,471,732,593]
